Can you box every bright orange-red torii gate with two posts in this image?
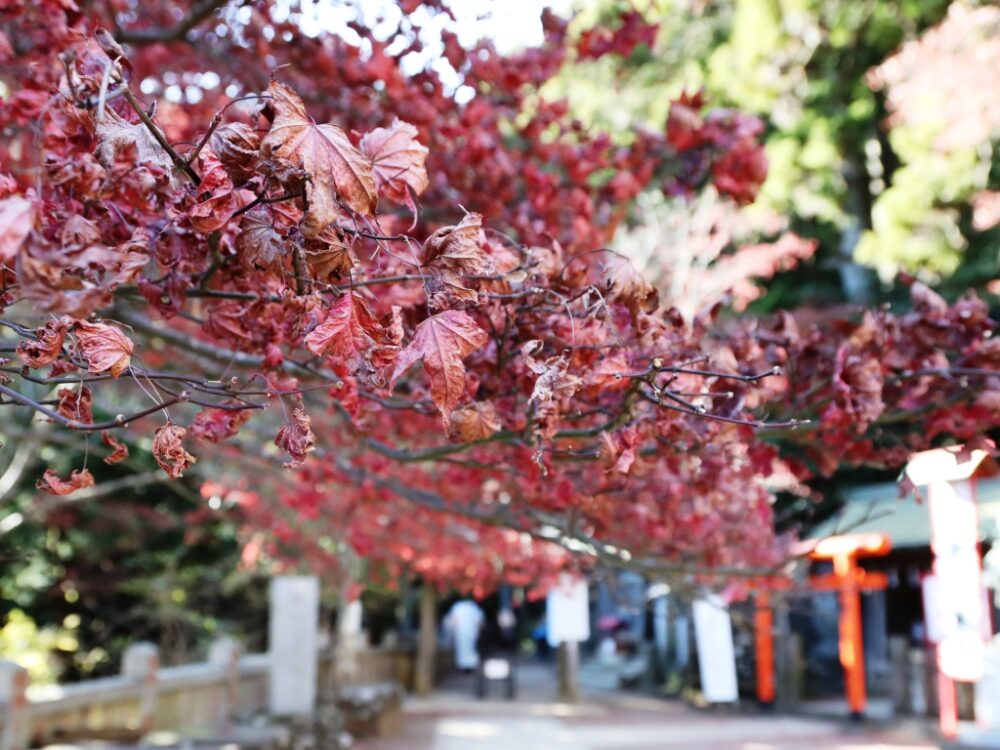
[754,534,892,718]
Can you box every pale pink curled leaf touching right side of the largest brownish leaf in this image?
[360,119,427,208]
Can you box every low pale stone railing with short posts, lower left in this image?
[0,639,410,750]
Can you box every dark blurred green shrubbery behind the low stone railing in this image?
[0,430,267,681]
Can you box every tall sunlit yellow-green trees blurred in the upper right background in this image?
[544,0,1000,309]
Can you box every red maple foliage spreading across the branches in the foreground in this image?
[0,0,1000,591]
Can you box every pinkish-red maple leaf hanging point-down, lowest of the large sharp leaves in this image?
[391,310,489,427]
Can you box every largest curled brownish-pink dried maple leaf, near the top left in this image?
[260,81,378,237]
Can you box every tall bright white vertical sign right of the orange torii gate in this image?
[925,479,985,682]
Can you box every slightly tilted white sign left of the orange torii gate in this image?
[692,594,739,703]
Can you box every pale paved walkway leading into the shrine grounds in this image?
[358,665,938,750]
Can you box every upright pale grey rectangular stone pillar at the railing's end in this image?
[268,576,319,716]
